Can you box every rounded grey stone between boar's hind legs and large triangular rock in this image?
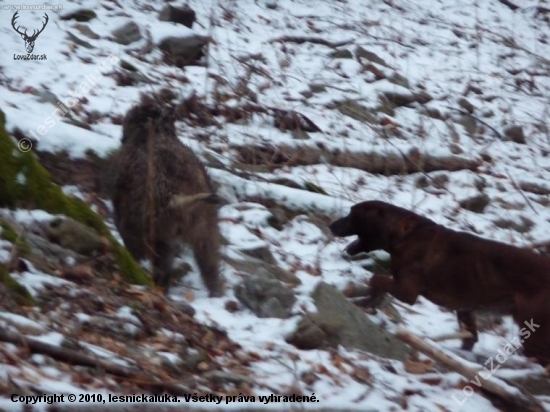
[234,275,296,319]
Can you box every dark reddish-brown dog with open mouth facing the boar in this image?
[330,201,550,363]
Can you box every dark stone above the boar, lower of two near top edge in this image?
[159,35,209,67]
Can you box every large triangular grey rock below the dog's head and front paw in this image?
[287,282,412,360]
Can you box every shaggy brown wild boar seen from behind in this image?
[113,96,223,296]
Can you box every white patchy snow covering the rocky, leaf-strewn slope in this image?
[0,0,550,411]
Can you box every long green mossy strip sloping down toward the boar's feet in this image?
[0,111,152,285]
